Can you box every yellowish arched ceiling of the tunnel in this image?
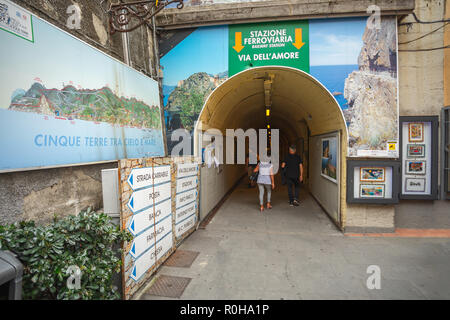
[200,67,346,139]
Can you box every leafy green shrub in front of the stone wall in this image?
[0,208,132,299]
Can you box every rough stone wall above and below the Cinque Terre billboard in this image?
[0,0,162,224]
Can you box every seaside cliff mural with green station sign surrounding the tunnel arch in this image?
[161,17,398,157]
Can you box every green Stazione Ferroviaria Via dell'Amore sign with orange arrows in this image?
[228,20,309,76]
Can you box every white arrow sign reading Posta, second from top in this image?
[128,183,171,213]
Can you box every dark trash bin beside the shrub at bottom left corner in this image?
[0,250,23,300]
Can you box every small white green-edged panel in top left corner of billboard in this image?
[0,0,34,42]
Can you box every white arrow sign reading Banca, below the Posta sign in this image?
[128,199,172,236]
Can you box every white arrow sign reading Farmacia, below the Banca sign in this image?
[130,215,172,259]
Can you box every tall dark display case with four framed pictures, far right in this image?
[400,116,439,200]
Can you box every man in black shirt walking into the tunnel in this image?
[281,145,303,206]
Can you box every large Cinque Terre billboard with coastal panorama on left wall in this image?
[0,0,164,171]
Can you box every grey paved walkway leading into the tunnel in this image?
[141,180,450,300]
